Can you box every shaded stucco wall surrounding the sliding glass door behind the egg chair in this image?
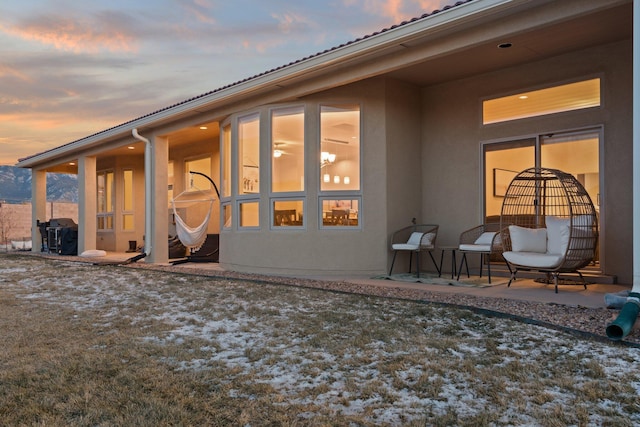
[422,41,632,283]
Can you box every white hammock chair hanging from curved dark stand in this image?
[171,171,220,265]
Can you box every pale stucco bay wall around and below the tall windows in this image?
[220,78,428,276]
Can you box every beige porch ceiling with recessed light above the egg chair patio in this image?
[387,3,633,86]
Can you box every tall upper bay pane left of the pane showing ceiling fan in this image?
[238,114,260,194]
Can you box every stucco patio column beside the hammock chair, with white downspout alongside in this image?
[145,136,169,263]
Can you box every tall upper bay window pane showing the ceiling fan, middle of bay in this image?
[271,107,304,192]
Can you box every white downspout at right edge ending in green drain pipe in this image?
[607,0,640,341]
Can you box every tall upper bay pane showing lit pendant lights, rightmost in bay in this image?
[320,105,360,191]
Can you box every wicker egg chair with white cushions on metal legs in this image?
[500,168,598,293]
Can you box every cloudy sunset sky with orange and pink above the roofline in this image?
[0,0,455,165]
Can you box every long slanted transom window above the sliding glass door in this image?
[482,79,600,125]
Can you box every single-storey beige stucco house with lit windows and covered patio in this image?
[18,0,640,283]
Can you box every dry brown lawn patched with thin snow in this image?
[0,255,640,427]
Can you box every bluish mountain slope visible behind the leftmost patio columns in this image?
[0,166,78,203]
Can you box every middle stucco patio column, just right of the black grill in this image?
[78,156,98,254]
